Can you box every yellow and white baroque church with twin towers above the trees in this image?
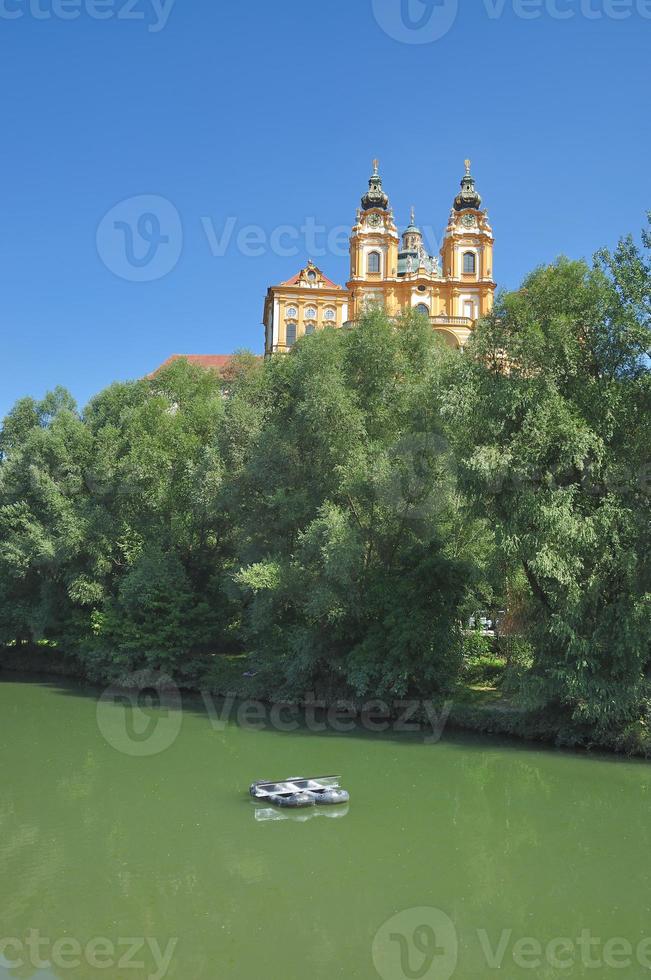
[263,160,495,356]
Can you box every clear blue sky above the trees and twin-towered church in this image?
[0,0,651,414]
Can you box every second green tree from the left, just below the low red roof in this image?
[81,361,234,675]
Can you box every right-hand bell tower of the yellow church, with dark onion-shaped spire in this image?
[441,160,495,321]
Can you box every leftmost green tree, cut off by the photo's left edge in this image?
[0,388,92,643]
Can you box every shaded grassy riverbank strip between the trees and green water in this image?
[0,646,651,758]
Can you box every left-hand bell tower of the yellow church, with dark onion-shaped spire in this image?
[347,160,400,320]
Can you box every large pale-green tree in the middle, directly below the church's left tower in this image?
[232,311,486,696]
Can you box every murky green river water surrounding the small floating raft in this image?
[0,675,651,980]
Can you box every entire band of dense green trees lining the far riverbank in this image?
[0,216,651,752]
